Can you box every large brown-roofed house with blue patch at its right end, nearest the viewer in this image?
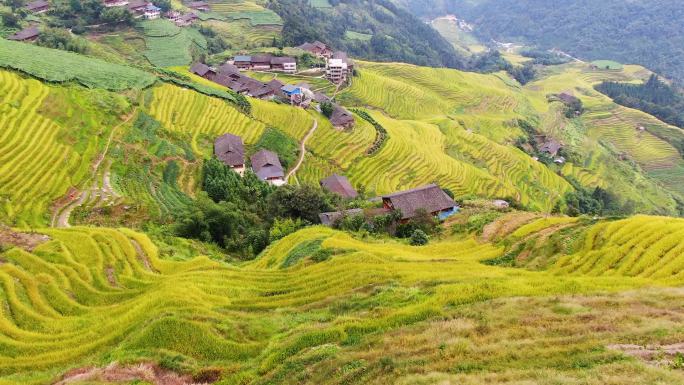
[382,184,458,221]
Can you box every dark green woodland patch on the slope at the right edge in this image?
[596,75,684,128]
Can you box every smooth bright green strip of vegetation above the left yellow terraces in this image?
[0,39,156,91]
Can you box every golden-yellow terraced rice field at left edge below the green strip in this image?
[0,71,106,226]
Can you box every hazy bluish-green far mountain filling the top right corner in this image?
[395,0,684,82]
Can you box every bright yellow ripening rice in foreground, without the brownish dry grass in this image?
[0,218,682,385]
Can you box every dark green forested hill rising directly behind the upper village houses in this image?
[269,0,466,68]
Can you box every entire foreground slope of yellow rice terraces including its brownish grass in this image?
[0,217,684,385]
